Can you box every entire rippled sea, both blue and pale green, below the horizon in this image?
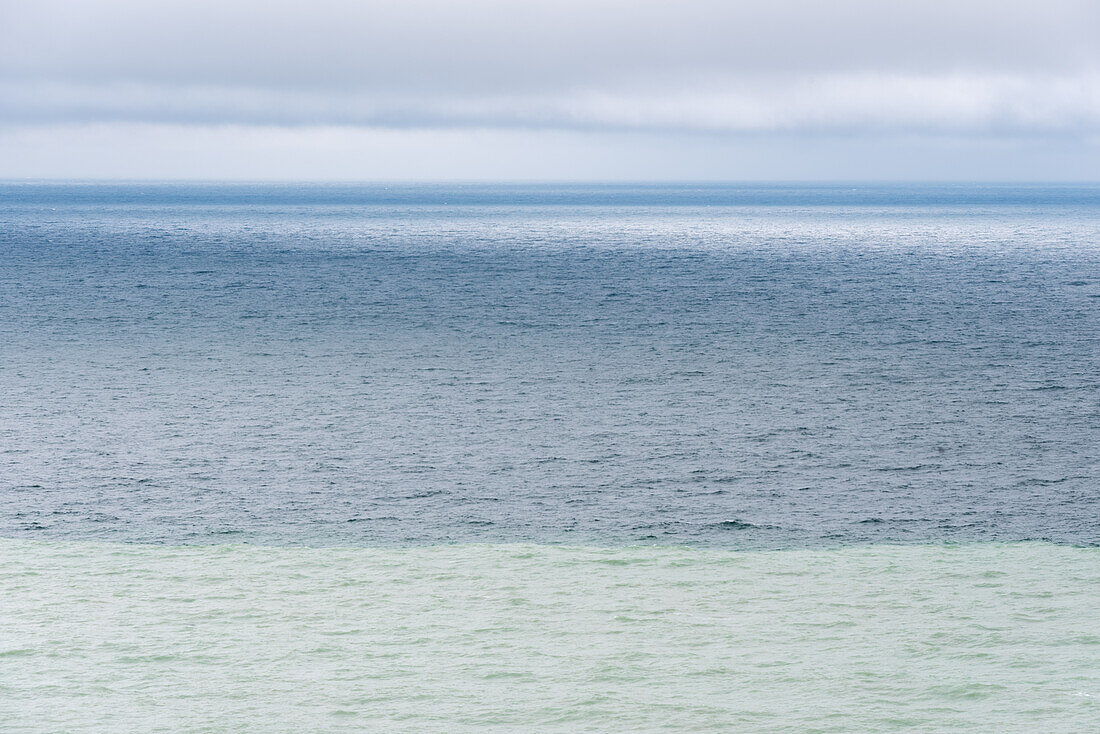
[0,184,1100,732]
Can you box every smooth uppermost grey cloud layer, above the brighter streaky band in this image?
[0,0,1100,90]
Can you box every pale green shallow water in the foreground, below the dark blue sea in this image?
[0,539,1100,732]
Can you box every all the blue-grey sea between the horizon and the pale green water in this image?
[0,184,1100,547]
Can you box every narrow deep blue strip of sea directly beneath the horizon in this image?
[0,182,1100,207]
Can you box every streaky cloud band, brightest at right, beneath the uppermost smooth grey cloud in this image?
[0,73,1100,135]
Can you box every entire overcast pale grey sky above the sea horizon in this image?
[0,0,1100,180]
